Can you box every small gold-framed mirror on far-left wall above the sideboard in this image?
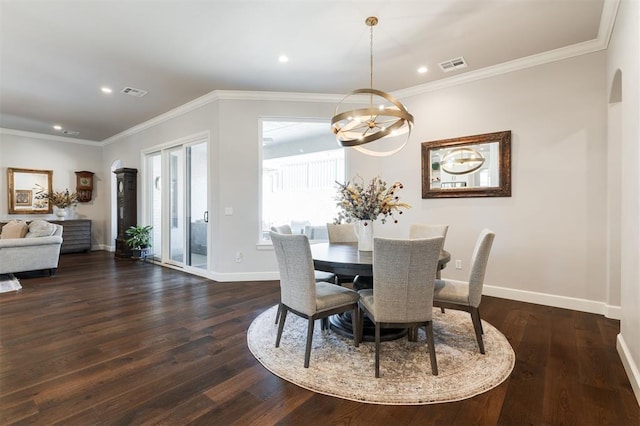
[7,167,53,214]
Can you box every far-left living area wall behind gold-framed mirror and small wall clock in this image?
[0,130,109,249]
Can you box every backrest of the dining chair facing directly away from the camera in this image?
[373,237,444,322]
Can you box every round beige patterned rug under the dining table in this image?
[247,306,515,405]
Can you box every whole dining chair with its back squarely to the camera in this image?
[358,237,444,378]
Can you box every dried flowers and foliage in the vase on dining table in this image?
[335,176,411,223]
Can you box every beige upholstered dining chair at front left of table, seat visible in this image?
[270,231,360,368]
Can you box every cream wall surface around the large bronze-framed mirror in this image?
[351,52,606,313]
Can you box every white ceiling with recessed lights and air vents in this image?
[0,0,617,141]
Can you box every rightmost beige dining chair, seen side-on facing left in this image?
[433,229,495,354]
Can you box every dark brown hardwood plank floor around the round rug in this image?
[0,252,640,425]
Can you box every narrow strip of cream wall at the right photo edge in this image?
[607,0,640,402]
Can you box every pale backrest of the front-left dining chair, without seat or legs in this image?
[269,231,316,315]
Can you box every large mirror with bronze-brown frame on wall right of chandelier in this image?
[422,130,511,198]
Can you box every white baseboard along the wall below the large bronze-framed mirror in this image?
[482,285,621,320]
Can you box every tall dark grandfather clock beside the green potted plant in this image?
[113,168,138,257]
